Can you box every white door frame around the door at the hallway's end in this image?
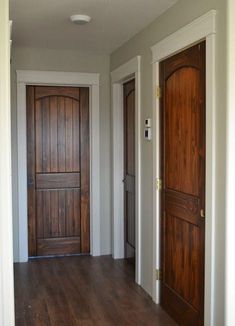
[16,70,100,262]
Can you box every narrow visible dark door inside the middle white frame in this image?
[123,80,135,258]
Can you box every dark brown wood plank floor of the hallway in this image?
[15,256,176,326]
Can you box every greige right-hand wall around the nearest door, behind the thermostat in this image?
[110,0,226,326]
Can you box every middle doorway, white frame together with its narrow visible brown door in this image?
[111,56,141,284]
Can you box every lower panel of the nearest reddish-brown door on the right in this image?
[164,214,201,310]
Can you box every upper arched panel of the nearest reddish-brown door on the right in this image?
[165,67,200,196]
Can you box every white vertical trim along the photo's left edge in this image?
[0,0,15,326]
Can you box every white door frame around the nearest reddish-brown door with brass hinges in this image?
[151,10,216,326]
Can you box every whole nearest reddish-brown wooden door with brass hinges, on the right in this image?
[160,42,205,326]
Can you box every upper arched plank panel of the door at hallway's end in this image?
[35,96,80,173]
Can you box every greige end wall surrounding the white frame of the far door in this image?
[11,47,111,261]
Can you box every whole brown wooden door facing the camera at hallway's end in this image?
[27,86,90,256]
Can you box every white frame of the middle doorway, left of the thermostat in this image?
[111,56,141,284]
